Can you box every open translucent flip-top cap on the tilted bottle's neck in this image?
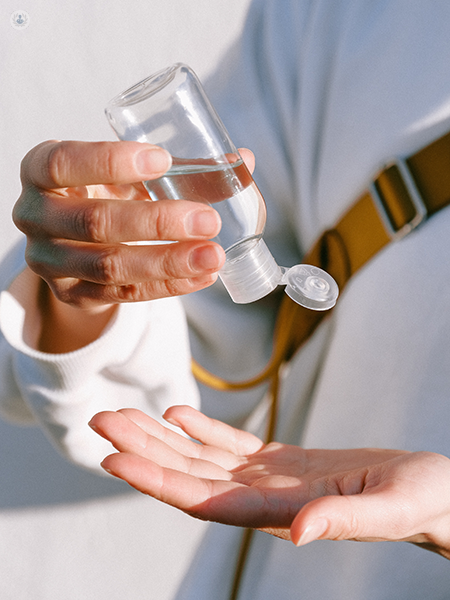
[219,238,339,310]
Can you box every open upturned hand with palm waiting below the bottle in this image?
[90,406,450,558]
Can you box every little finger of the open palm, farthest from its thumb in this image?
[164,406,264,456]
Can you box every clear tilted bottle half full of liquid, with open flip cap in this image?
[105,63,338,310]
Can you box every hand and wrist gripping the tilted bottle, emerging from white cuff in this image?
[13,141,254,353]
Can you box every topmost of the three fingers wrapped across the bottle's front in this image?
[21,141,172,189]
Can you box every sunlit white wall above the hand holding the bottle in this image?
[0,0,253,256]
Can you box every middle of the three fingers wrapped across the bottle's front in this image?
[13,193,221,243]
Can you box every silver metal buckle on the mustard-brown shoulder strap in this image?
[369,158,428,241]
